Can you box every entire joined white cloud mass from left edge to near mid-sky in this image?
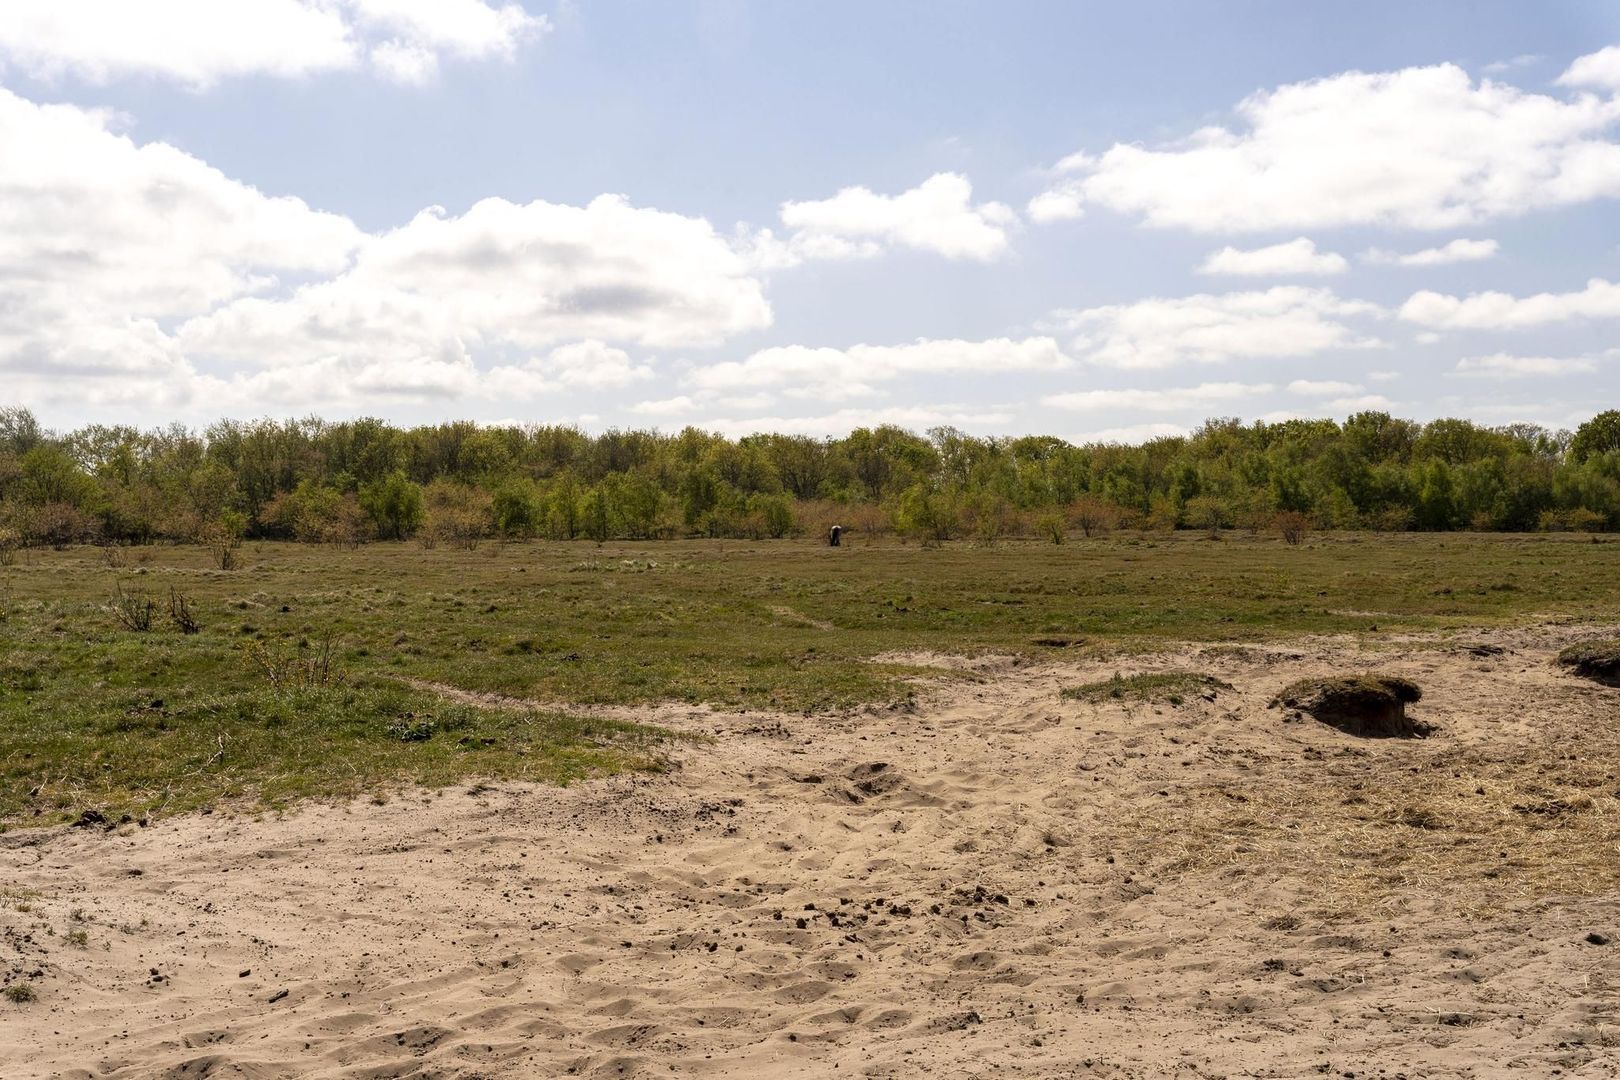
[0,89,771,410]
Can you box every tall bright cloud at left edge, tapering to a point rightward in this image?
[0,89,365,397]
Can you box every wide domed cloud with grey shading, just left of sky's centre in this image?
[180,196,771,380]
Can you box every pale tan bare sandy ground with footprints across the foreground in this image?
[0,627,1620,1080]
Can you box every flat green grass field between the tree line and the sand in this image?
[0,534,1620,824]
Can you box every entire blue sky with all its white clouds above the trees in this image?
[0,0,1620,442]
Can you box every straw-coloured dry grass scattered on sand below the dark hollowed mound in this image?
[1115,730,1620,916]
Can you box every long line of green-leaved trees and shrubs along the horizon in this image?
[0,406,1620,551]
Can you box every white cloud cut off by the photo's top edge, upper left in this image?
[0,0,548,87]
